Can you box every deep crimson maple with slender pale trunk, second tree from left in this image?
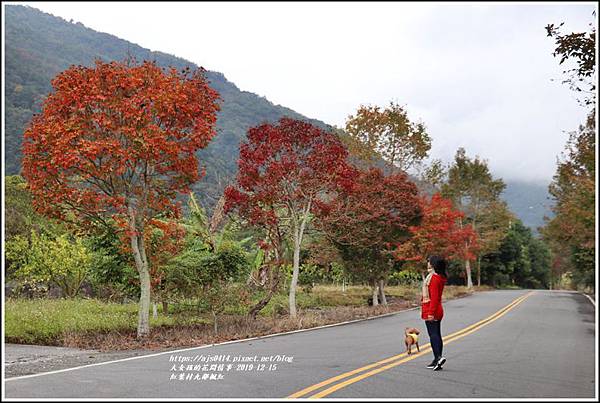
[225,118,352,317]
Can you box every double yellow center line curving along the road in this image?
[288,291,534,399]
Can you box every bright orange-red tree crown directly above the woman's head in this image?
[394,193,477,271]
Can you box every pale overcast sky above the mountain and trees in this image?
[21,2,597,182]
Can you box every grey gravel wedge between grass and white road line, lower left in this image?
[4,343,168,378]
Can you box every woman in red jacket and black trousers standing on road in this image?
[421,256,448,371]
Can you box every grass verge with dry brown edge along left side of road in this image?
[5,285,477,351]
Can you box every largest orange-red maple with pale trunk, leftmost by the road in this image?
[23,61,219,337]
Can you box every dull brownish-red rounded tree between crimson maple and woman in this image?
[318,168,421,305]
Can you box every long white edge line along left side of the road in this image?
[4,307,419,382]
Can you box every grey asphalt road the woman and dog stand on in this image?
[4,290,597,399]
